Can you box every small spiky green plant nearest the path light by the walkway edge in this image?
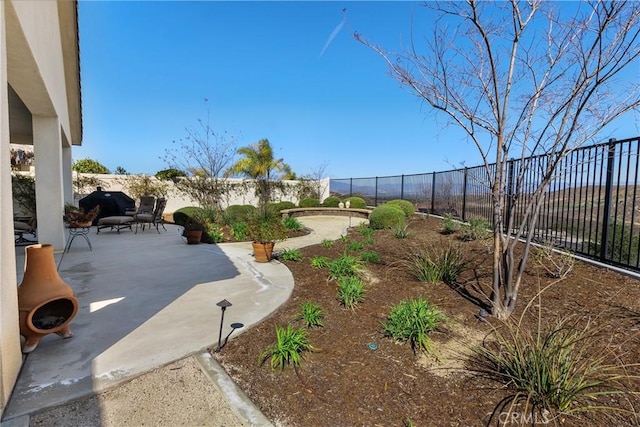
[258,325,313,370]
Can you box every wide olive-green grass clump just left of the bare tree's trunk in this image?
[404,244,467,285]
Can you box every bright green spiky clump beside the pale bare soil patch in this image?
[383,298,445,356]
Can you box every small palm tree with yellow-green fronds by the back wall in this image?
[226,139,295,207]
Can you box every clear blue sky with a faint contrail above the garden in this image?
[73,1,637,178]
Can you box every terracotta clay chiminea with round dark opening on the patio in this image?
[18,244,78,353]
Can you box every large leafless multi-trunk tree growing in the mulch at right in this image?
[355,0,640,318]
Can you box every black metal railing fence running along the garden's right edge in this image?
[330,137,640,271]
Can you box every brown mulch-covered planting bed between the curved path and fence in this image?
[215,218,640,426]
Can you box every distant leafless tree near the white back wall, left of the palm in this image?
[163,101,238,209]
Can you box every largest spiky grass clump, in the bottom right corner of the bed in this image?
[469,309,637,419]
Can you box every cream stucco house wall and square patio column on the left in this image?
[0,0,82,415]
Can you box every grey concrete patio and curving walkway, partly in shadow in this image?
[2,216,362,427]
